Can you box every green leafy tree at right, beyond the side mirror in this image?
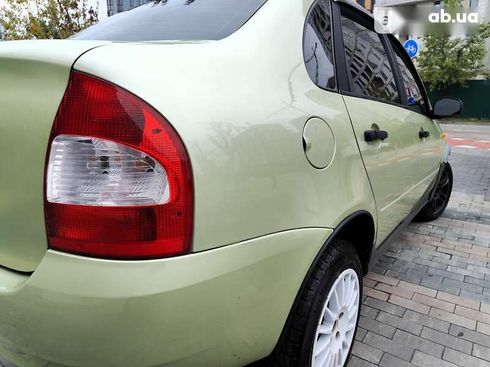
[417,0,490,90]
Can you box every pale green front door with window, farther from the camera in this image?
[390,37,444,193]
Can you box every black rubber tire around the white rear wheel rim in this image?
[269,239,362,367]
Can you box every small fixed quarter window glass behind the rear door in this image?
[303,0,336,89]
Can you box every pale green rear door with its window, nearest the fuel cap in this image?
[334,3,419,243]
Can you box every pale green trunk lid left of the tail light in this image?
[0,41,103,272]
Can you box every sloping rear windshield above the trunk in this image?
[73,0,267,42]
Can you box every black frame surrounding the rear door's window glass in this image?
[331,0,412,111]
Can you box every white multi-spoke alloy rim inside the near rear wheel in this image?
[311,269,360,367]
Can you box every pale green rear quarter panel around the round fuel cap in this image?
[74,0,375,251]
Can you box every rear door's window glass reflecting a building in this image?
[342,16,400,103]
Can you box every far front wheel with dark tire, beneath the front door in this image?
[414,163,453,222]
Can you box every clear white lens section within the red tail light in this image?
[46,135,170,206]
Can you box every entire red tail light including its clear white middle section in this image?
[45,72,193,259]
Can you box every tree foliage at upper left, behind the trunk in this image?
[0,0,98,40]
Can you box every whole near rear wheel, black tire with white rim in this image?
[274,240,362,367]
